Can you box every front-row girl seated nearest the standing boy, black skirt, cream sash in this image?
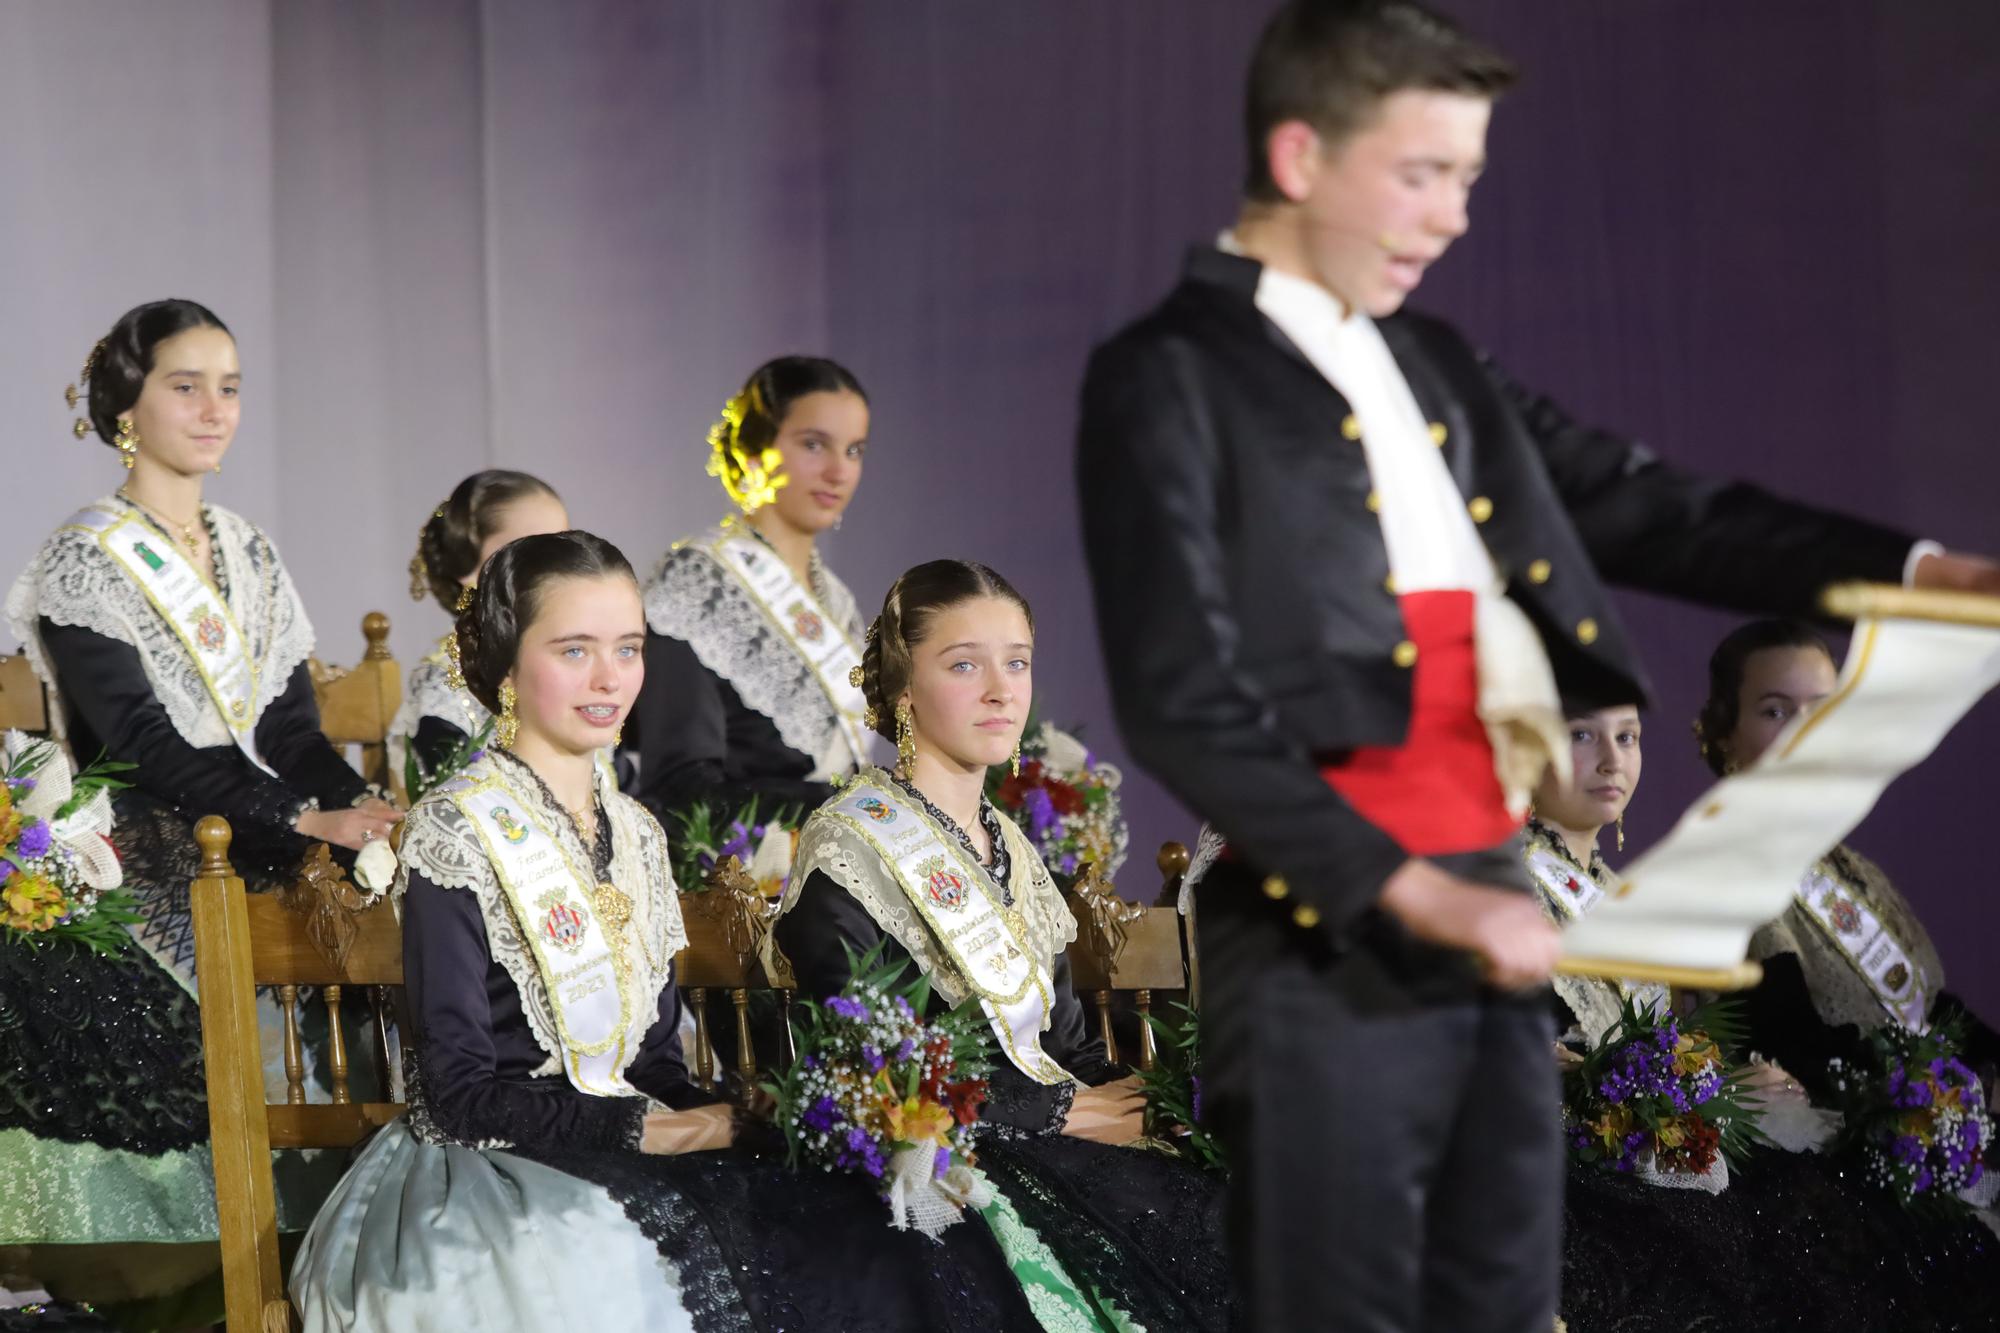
[776,560,1230,1329]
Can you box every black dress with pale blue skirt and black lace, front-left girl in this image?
[292,757,1176,1333]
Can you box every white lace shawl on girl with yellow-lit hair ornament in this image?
[646,526,866,783]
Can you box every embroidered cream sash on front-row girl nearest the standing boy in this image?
[820,773,1072,1083]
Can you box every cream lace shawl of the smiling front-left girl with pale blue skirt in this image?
[394,751,688,1075]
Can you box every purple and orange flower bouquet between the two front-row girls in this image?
[766,949,1008,1237]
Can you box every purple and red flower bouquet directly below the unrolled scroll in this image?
[1562,997,1764,1189]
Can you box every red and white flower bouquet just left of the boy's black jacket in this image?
[986,723,1132,881]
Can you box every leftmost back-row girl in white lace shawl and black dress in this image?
[0,300,396,1323]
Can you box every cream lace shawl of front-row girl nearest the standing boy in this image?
[778,769,1076,1005]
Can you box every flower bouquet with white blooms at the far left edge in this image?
[0,731,138,953]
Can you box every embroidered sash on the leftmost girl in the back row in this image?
[68,508,278,777]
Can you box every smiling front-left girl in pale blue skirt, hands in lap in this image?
[292,530,732,1333]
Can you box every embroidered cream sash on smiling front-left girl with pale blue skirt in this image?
[448,771,654,1097]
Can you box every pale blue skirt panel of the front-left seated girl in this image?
[292,1121,694,1333]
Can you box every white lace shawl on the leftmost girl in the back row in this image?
[6,496,312,749]
